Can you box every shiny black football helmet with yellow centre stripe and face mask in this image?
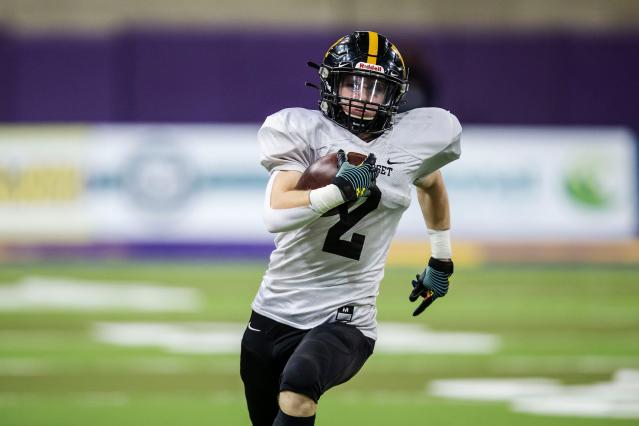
[309,31,408,134]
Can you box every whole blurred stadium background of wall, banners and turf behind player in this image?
[0,0,639,425]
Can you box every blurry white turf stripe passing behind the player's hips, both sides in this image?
[93,323,499,354]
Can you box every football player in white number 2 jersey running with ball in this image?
[240,31,461,425]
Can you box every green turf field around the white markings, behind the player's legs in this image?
[0,262,639,426]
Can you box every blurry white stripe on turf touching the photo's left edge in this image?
[0,277,200,312]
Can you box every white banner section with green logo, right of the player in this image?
[399,127,637,241]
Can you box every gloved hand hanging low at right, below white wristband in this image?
[408,257,454,316]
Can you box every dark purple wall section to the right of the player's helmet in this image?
[400,33,639,130]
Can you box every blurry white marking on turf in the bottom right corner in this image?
[429,369,639,419]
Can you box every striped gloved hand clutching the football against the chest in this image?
[333,149,379,201]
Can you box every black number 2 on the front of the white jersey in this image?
[322,186,382,260]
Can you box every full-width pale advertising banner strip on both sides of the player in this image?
[0,125,637,243]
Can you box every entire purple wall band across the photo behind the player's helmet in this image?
[0,30,639,130]
